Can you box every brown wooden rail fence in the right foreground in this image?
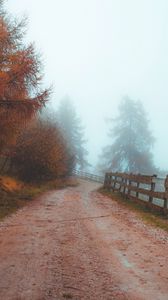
[104,173,168,213]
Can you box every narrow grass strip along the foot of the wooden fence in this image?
[98,188,168,232]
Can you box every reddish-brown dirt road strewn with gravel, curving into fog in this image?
[0,181,168,300]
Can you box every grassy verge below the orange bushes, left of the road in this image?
[0,178,78,220]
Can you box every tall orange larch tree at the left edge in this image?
[0,1,49,153]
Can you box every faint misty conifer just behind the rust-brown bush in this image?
[57,97,89,169]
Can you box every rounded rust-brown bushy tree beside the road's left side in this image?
[11,120,74,181]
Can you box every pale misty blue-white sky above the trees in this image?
[6,0,168,169]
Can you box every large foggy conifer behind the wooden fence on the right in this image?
[102,97,155,174]
